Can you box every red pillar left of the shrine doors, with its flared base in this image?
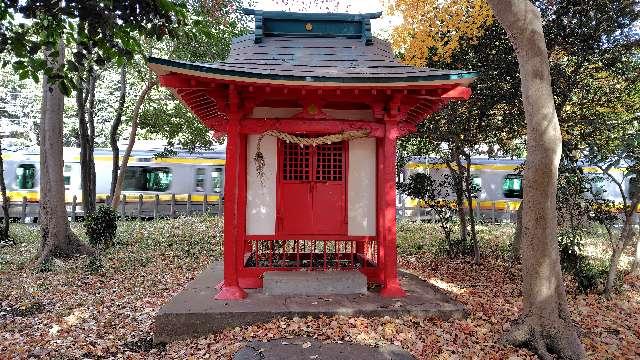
[215,116,247,300]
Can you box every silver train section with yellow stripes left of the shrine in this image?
[4,148,225,217]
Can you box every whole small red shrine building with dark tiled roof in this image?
[149,10,476,300]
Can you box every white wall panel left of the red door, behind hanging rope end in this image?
[247,135,278,235]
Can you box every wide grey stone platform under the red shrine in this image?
[153,262,466,342]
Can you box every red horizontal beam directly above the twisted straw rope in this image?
[240,118,384,137]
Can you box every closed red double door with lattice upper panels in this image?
[278,142,347,236]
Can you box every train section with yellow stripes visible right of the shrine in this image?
[398,157,639,216]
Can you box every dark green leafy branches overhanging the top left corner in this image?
[0,0,186,95]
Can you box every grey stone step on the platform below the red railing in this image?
[262,270,367,296]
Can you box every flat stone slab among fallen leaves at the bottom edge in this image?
[233,338,414,360]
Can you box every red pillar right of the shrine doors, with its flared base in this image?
[380,119,407,298]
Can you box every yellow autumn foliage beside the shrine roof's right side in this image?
[389,0,493,66]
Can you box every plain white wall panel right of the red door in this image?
[348,138,376,236]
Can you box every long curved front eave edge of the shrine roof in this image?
[148,57,478,87]
